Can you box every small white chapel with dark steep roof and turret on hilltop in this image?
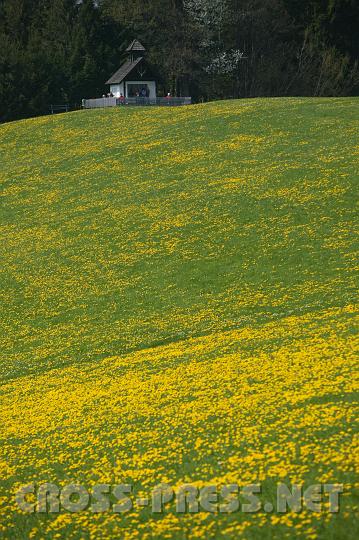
[106,39,157,98]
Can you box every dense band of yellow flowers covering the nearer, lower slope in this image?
[0,306,359,539]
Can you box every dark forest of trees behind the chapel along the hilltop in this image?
[0,0,359,121]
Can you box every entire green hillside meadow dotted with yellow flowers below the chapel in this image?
[0,98,359,540]
